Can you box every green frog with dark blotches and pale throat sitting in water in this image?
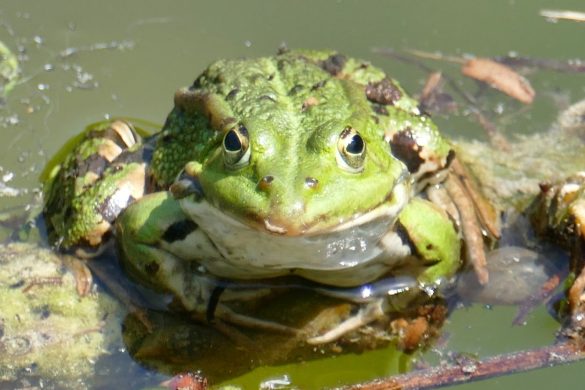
[45,51,462,313]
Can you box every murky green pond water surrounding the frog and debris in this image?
[0,0,585,389]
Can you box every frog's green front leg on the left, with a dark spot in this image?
[116,191,295,333]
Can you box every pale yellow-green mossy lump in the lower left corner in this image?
[0,243,122,388]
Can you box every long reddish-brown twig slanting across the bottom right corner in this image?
[344,339,585,390]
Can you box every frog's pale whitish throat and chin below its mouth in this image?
[181,183,410,285]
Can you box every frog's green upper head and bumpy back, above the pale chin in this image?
[154,52,418,236]
